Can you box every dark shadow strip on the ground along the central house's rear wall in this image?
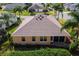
[13,44,67,51]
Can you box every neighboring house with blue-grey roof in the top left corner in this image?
[2,3,25,10]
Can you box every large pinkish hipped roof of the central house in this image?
[12,15,70,36]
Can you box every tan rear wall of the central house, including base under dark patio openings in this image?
[13,36,69,47]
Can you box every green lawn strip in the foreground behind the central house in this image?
[2,47,71,56]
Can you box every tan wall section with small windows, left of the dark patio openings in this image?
[13,36,50,45]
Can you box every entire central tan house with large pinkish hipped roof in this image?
[12,15,71,47]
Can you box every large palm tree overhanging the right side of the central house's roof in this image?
[61,11,79,44]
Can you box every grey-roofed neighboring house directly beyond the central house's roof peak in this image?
[28,3,44,12]
